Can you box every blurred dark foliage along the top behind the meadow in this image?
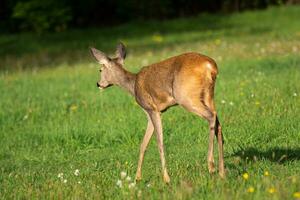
[0,0,299,33]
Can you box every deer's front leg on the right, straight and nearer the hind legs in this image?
[149,111,170,183]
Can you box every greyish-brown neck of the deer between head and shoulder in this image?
[116,69,136,96]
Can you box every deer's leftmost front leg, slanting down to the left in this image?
[135,113,154,181]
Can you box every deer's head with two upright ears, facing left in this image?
[90,43,126,89]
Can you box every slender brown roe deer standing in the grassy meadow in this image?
[90,43,225,183]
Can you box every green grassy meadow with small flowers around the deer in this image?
[0,7,300,199]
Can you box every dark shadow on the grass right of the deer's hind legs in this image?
[232,147,300,164]
